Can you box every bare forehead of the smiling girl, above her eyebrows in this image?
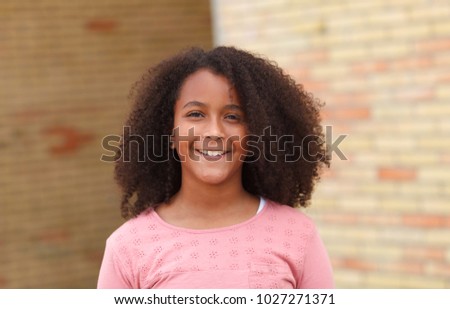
[177,69,240,105]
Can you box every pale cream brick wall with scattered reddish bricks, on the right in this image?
[212,0,450,288]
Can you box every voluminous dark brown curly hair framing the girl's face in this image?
[115,46,330,218]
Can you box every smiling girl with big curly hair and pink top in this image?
[98,47,333,289]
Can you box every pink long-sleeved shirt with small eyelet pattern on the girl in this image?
[97,201,334,289]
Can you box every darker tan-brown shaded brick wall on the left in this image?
[0,0,212,288]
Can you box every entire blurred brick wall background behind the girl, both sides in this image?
[0,0,450,288]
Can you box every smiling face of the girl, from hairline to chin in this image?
[173,69,247,185]
